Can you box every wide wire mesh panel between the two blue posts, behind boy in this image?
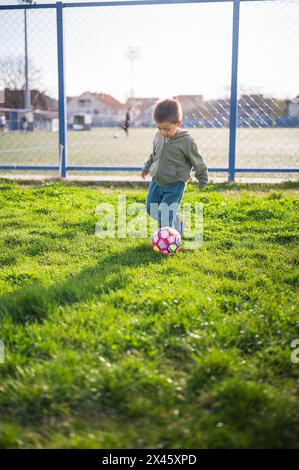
[65,3,232,173]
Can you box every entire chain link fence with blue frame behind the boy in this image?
[0,0,299,179]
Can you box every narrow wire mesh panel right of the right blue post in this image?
[236,0,299,176]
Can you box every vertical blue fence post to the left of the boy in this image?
[56,2,67,178]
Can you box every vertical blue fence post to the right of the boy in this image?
[228,0,240,181]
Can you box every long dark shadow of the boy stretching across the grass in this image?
[0,244,162,324]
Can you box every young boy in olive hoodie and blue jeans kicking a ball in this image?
[141,99,208,235]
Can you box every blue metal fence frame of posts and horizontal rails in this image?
[0,0,299,181]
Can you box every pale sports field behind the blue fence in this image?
[0,128,299,177]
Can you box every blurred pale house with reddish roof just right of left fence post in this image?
[67,91,127,127]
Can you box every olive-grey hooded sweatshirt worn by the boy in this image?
[143,130,208,188]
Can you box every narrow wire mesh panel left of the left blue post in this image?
[0,5,58,173]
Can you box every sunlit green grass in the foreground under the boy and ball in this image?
[0,180,299,448]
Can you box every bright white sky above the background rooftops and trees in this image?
[0,0,299,102]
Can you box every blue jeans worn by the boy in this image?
[146,178,186,232]
